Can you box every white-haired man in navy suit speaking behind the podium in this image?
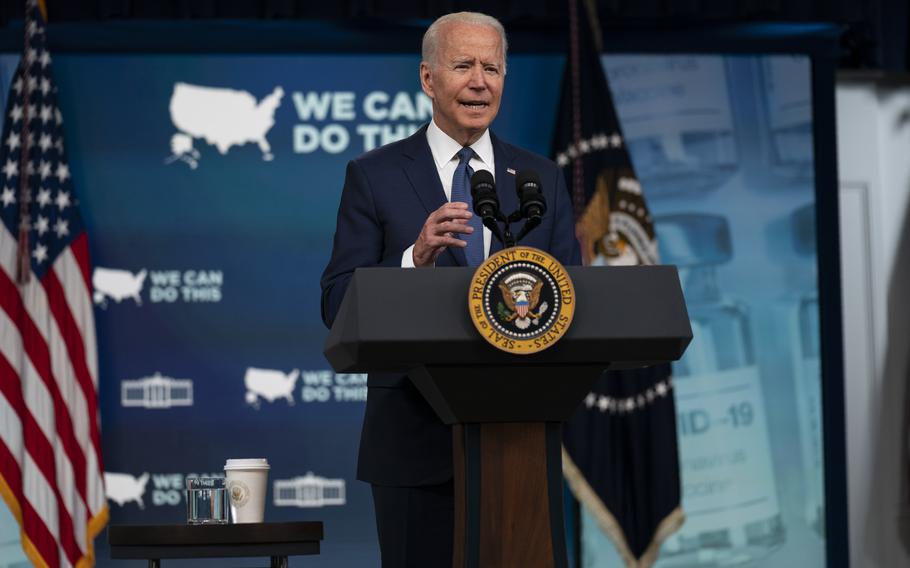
[321,12,581,568]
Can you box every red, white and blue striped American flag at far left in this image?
[0,0,108,567]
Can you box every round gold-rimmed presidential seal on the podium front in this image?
[468,247,575,355]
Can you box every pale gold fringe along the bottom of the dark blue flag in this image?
[562,447,686,568]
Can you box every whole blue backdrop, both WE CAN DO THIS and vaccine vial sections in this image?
[0,54,824,567]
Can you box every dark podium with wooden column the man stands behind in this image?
[325,266,692,568]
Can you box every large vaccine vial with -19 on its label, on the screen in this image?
[656,214,785,567]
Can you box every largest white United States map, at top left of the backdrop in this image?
[165,83,284,169]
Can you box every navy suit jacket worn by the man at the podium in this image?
[321,127,581,486]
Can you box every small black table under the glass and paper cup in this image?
[108,521,322,568]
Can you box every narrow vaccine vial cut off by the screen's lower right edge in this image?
[785,204,825,536]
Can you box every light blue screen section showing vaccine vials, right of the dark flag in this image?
[582,55,825,568]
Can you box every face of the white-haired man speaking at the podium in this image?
[420,23,505,146]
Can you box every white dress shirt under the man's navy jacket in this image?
[401,120,496,268]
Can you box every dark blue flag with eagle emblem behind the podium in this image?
[553,0,684,567]
